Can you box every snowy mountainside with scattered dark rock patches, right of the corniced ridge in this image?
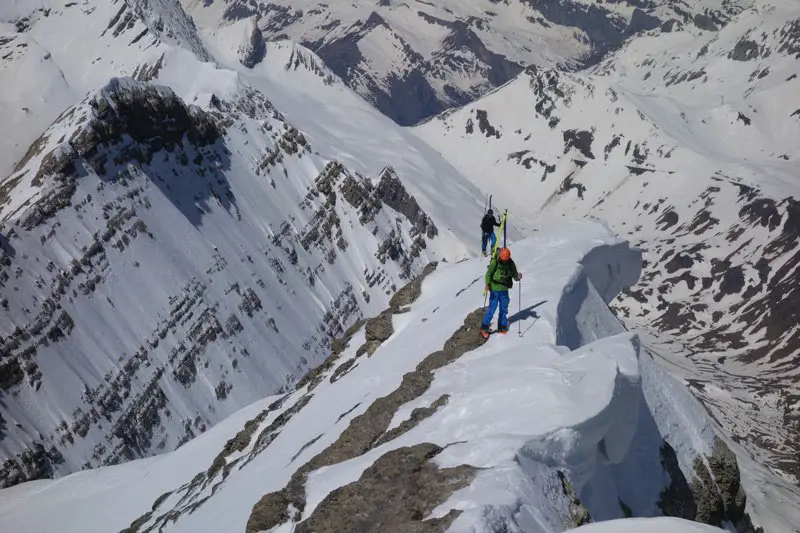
[416,1,800,494]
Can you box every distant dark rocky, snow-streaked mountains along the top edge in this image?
[182,0,740,125]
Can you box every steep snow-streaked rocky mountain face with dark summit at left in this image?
[0,79,437,486]
